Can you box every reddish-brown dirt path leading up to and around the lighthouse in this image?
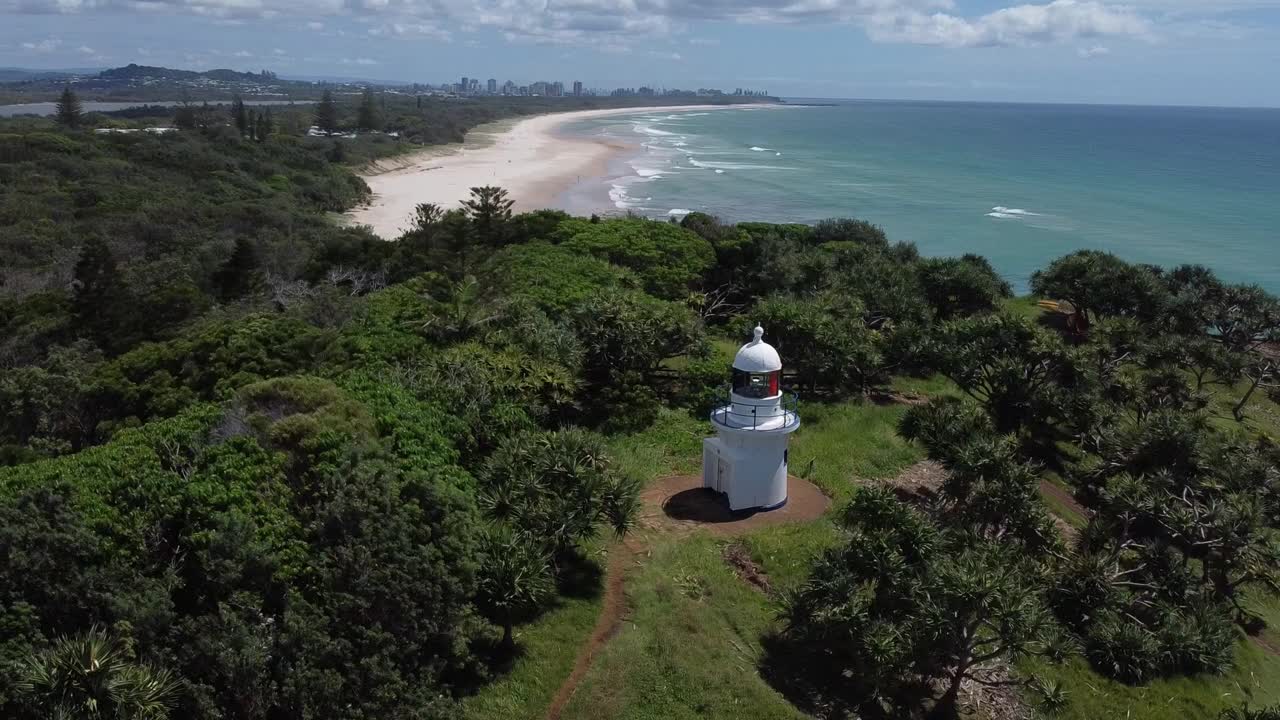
[544,475,831,720]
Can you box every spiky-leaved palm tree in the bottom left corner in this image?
[18,625,179,720]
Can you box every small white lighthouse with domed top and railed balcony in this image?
[703,325,800,511]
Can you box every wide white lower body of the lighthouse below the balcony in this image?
[703,434,787,511]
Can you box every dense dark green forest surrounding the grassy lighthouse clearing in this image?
[0,95,1280,720]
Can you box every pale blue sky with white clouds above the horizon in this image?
[0,0,1280,106]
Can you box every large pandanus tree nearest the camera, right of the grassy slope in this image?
[783,488,1064,717]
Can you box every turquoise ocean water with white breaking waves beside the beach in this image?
[570,101,1280,292]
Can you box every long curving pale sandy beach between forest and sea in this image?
[347,105,752,240]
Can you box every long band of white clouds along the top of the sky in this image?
[0,0,1172,50]
